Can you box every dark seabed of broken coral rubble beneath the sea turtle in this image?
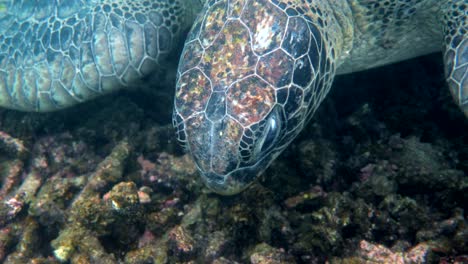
[0,54,468,264]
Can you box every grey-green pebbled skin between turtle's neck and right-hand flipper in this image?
[337,0,446,74]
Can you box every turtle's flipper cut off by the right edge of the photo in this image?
[444,0,468,117]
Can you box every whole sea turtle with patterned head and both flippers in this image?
[0,0,468,194]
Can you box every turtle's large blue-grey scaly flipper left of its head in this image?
[0,0,195,111]
